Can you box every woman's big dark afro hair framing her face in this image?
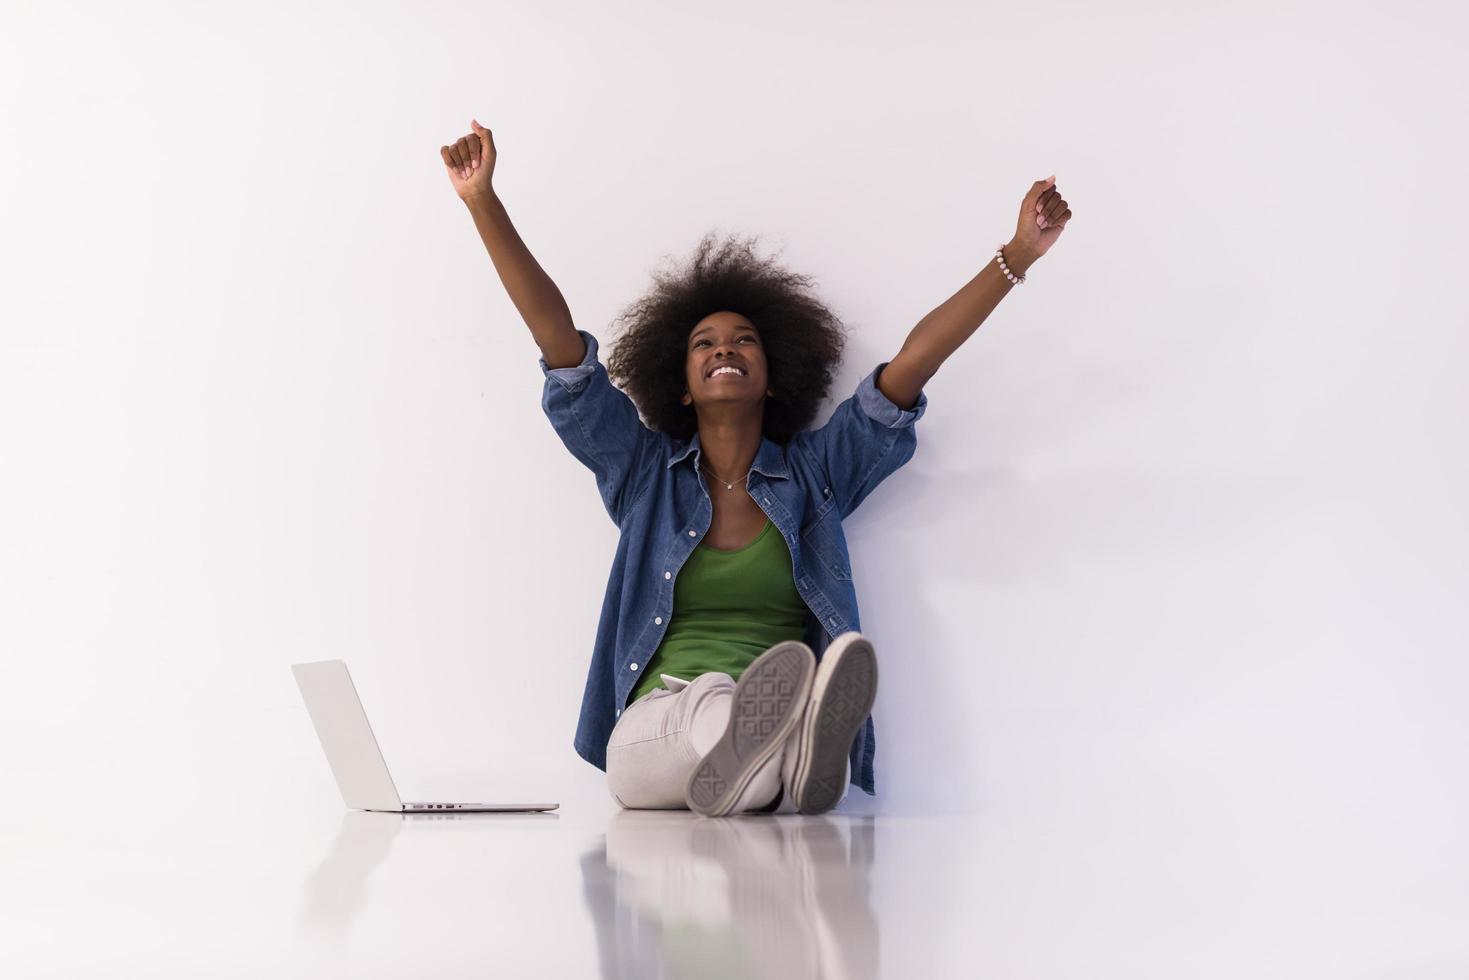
[607,232,846,445]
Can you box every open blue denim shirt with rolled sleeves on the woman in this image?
[539,329,928,795]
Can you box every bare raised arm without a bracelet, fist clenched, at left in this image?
[439,119,586,367]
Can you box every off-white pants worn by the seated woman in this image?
[607,671,852,814]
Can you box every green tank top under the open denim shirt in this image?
[627,519,806,704]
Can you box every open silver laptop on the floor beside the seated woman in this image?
[291,660,561,813]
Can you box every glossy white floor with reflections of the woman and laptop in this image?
[0,767,1469,980]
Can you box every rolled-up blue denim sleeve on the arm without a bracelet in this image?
[538,329,661,526]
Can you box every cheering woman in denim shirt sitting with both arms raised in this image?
[439,120,1071,817]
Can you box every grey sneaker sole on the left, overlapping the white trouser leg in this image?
[685,641,817,817]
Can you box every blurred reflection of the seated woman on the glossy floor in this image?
[582,810,878,980]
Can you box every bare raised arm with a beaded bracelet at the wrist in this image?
[877,176,1071,410]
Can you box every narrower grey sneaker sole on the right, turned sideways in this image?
[792,638,877,814]
